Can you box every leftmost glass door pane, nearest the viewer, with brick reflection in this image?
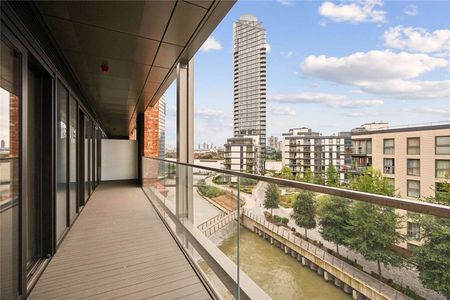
[0,38,21,299]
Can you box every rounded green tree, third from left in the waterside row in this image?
[317,196,350,254]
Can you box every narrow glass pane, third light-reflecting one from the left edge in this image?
[69,97,78,223]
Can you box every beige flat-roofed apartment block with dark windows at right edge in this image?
[352,124,450,249]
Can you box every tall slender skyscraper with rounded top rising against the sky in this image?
[225,14,267,174]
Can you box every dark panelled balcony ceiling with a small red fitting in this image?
[36,0,235,138]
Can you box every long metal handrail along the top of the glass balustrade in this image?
[145,157,450,219]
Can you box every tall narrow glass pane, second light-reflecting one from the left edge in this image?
[56,82,69,240]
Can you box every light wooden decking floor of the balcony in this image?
[29,182,210,299]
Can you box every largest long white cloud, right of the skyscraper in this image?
[301,50,450,98]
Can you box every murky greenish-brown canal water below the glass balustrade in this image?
[211,228,351,300]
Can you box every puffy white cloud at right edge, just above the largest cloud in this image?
[383,26,450,53]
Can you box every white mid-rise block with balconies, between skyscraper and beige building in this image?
[282,127,351,182]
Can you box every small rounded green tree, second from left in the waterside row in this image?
[291,191,316,236]
